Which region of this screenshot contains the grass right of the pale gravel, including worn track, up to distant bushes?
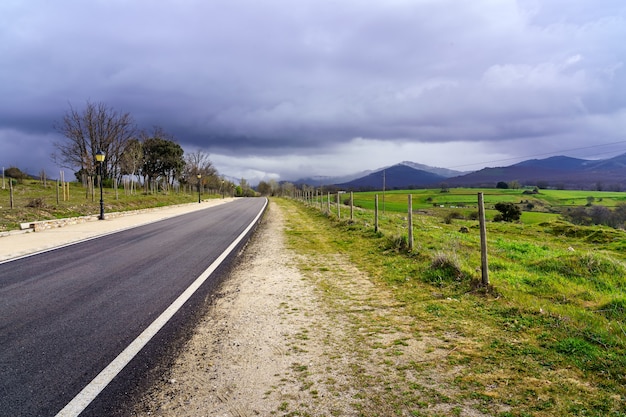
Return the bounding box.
[277,196,626,417]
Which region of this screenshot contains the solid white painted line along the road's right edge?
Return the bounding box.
[56,199,268,417]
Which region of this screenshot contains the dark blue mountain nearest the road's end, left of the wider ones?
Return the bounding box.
[336,163,446,191]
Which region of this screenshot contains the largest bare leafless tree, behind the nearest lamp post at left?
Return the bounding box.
[52,101,135,178]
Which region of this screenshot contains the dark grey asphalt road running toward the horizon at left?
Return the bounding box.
[0,198,266,416]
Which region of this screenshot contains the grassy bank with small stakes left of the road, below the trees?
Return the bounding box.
[0,179,220,232]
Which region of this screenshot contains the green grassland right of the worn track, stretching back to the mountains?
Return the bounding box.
[280,190,626,417]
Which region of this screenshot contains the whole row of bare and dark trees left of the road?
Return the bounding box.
[52,101,234,189]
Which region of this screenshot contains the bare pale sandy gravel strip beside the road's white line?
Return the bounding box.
[136,203,343,417]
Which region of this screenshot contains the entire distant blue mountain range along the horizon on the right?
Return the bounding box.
[295,153,626,191]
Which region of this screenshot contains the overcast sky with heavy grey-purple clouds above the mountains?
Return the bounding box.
[0,0,626,182]
